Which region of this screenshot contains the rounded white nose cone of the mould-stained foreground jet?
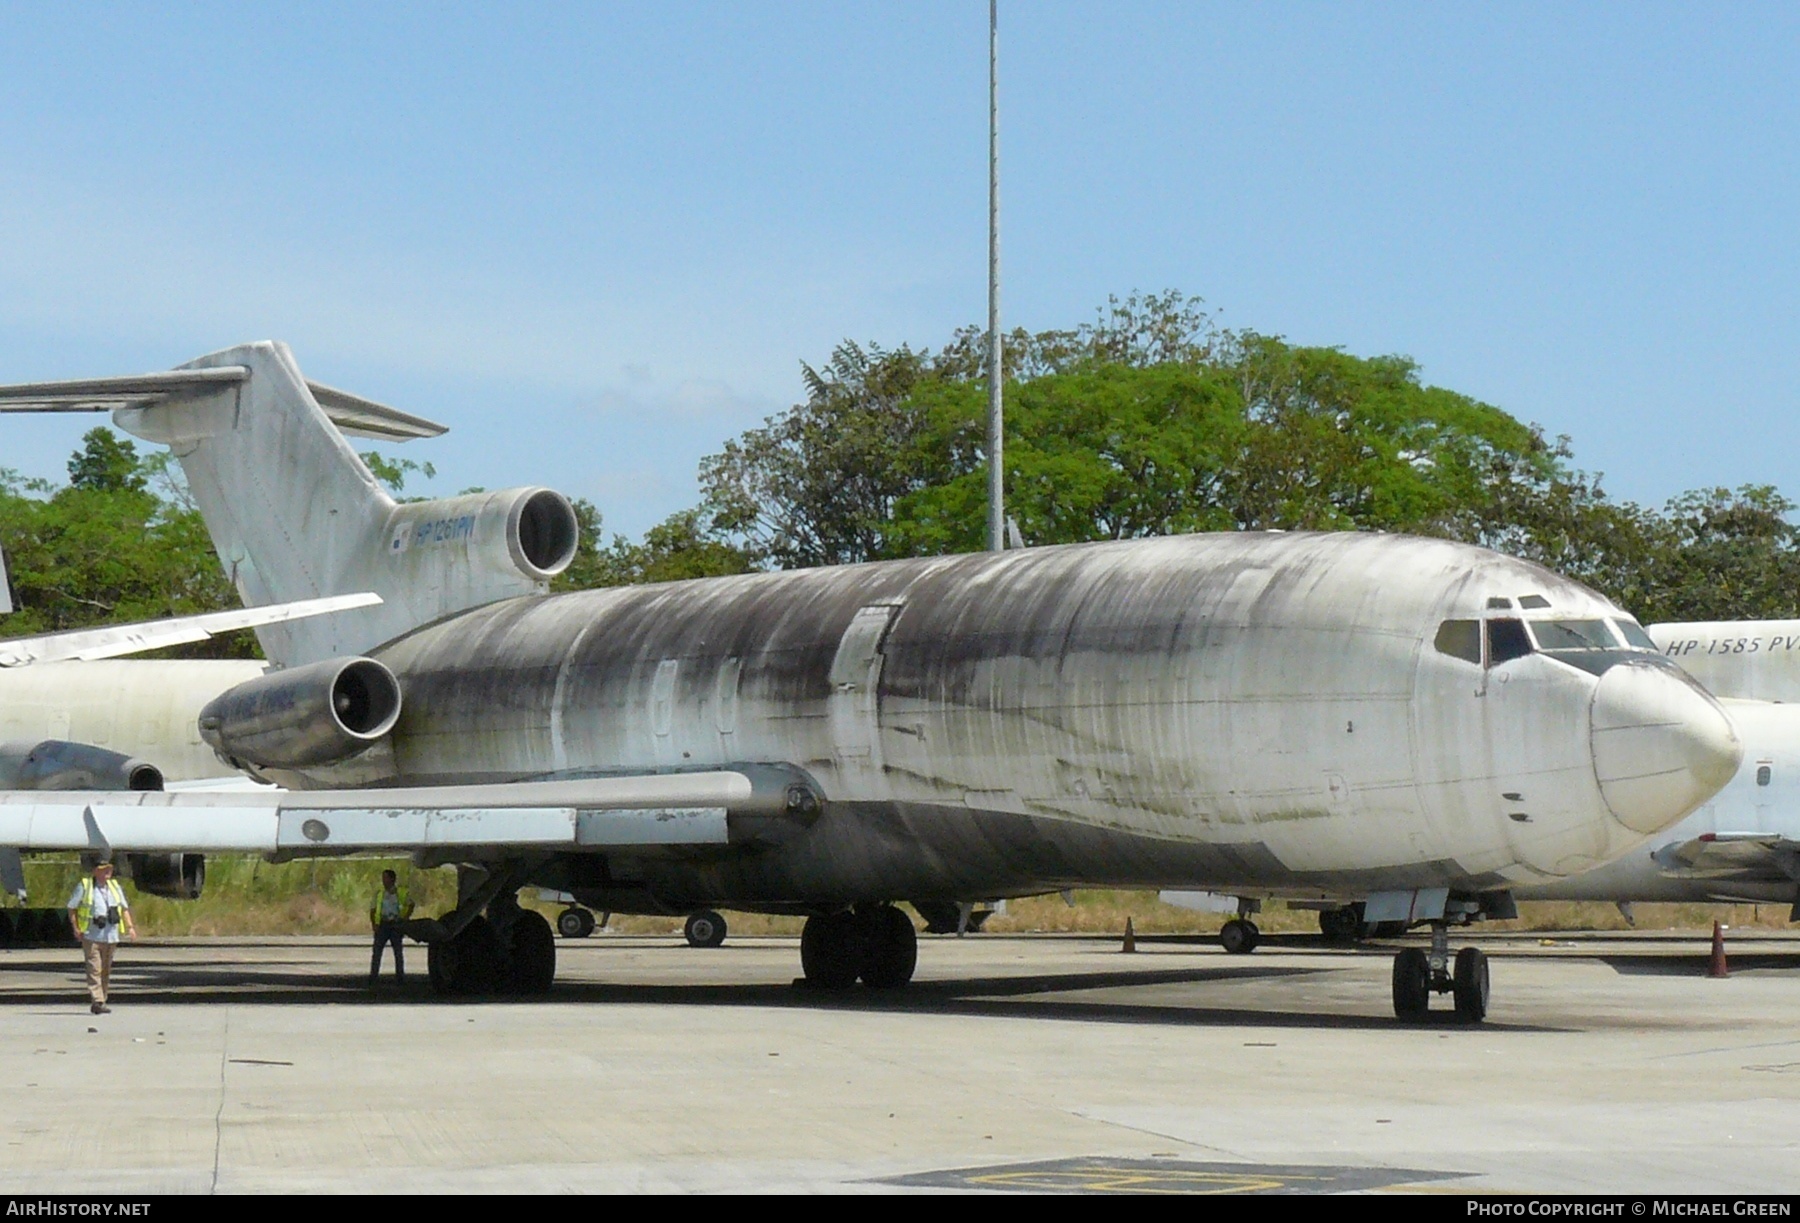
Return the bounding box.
[1593,665,1744,832]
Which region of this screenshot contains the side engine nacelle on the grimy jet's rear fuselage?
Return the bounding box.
[200,657,400,769]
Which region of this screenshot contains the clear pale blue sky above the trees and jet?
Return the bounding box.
[0,0,1800,535]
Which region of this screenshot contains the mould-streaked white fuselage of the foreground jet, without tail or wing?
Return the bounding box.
[272,533,1739,911]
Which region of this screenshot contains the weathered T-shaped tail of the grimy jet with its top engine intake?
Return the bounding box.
[0,340,576,666]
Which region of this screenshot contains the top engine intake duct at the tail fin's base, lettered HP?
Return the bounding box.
[383,488,581,584]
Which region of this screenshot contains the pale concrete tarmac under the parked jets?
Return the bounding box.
[0,933,1800,1194]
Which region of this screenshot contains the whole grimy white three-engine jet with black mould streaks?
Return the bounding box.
[0,344,1741,1019]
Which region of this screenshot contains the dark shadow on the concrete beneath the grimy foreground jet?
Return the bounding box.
[0,947,1562,1032]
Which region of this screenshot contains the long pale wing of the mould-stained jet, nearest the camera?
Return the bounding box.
[0,771,756,857]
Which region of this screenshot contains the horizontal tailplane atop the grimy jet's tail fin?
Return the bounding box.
[0,366,448,441]
